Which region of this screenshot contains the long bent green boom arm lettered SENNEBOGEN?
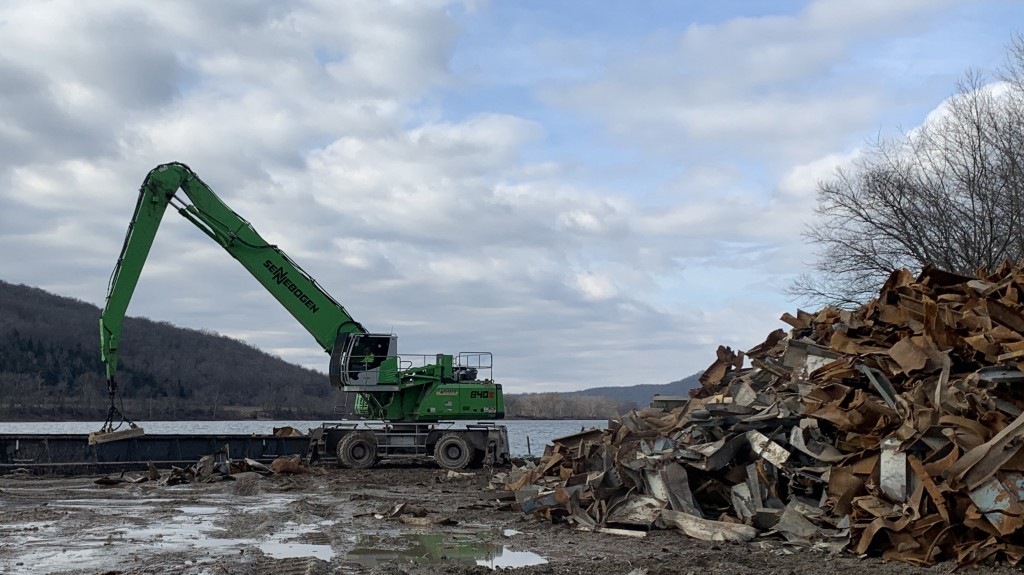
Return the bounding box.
[99,163,367,382]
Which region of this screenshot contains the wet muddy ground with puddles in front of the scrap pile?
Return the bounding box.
[0,465,1021,575]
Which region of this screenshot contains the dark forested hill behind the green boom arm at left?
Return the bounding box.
[0,281,344,421]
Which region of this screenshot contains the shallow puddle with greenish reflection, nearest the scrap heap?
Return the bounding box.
[347,533,548,569]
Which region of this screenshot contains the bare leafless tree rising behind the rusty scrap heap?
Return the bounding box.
[790,36,1024,306]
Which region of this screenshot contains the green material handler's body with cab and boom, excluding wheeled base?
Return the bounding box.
[99,163,505,422]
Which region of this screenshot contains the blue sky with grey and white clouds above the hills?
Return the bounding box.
[0,0,1024,393]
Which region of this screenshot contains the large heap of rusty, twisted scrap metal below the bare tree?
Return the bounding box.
[505,264,1024,565]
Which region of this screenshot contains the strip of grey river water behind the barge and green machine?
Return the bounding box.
[0,419,608,456]
